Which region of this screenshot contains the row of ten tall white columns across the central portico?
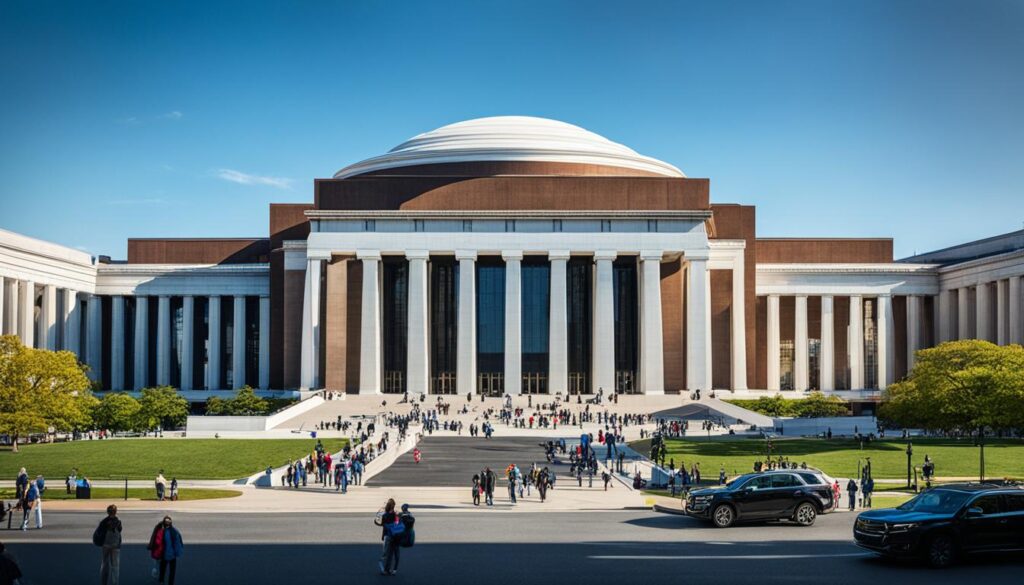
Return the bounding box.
[300,250,746,394]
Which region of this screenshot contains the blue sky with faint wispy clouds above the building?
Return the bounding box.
[0,0,1024,258]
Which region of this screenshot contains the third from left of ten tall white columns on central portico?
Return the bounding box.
[406,250,428,394]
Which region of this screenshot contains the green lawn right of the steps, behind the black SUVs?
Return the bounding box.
[632,438,1024,485]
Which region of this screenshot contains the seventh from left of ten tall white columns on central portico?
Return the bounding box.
[591,250,617,394]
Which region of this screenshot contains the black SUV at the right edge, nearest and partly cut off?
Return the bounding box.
[853,484,1024,568]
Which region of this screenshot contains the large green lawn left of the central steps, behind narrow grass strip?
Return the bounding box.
[0,438,345,481]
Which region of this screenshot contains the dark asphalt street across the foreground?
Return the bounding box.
[0,508,1024,585]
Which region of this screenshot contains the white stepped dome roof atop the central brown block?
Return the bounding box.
[334,116,686,178]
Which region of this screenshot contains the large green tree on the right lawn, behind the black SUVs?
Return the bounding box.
[879,339,1024,477]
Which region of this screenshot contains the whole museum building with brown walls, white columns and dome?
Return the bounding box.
[0,117,1024,402]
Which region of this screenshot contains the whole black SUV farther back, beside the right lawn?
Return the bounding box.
[685,469,833,528]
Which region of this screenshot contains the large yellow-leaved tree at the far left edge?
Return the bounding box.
[0,335,96,452]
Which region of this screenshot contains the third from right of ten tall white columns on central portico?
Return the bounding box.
[640,250,665,394]
